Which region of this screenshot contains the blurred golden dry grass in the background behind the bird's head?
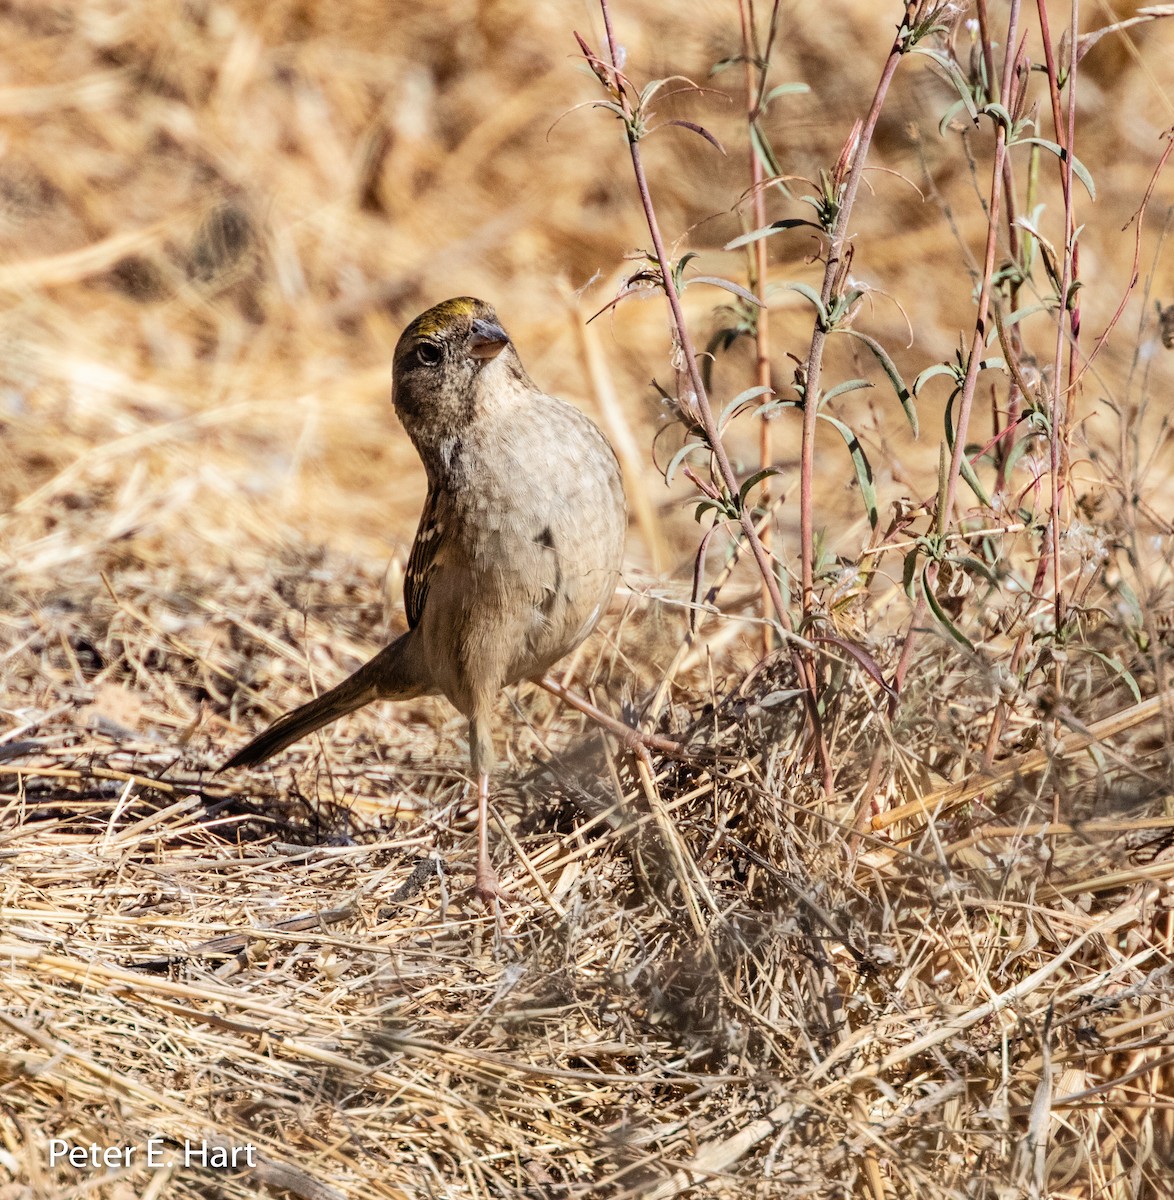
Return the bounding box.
[0,0,1174,600]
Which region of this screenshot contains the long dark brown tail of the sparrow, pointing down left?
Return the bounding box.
[216,632,430,774]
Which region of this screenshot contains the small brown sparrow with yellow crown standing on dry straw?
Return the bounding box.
[221,296,627,901]
